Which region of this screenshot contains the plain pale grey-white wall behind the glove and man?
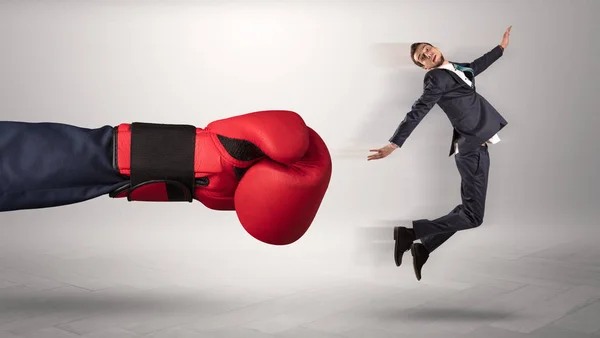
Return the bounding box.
[0,0,600,240]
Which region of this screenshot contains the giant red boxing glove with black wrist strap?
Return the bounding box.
[110,110,332,245]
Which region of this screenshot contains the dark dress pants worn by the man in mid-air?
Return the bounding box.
[413,144,490,252]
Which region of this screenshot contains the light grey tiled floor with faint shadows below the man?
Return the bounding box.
[0,201,600,338]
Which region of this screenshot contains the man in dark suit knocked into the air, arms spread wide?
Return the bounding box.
[367,26,512,280]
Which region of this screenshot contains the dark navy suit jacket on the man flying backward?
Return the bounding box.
[389,45,508,156]
